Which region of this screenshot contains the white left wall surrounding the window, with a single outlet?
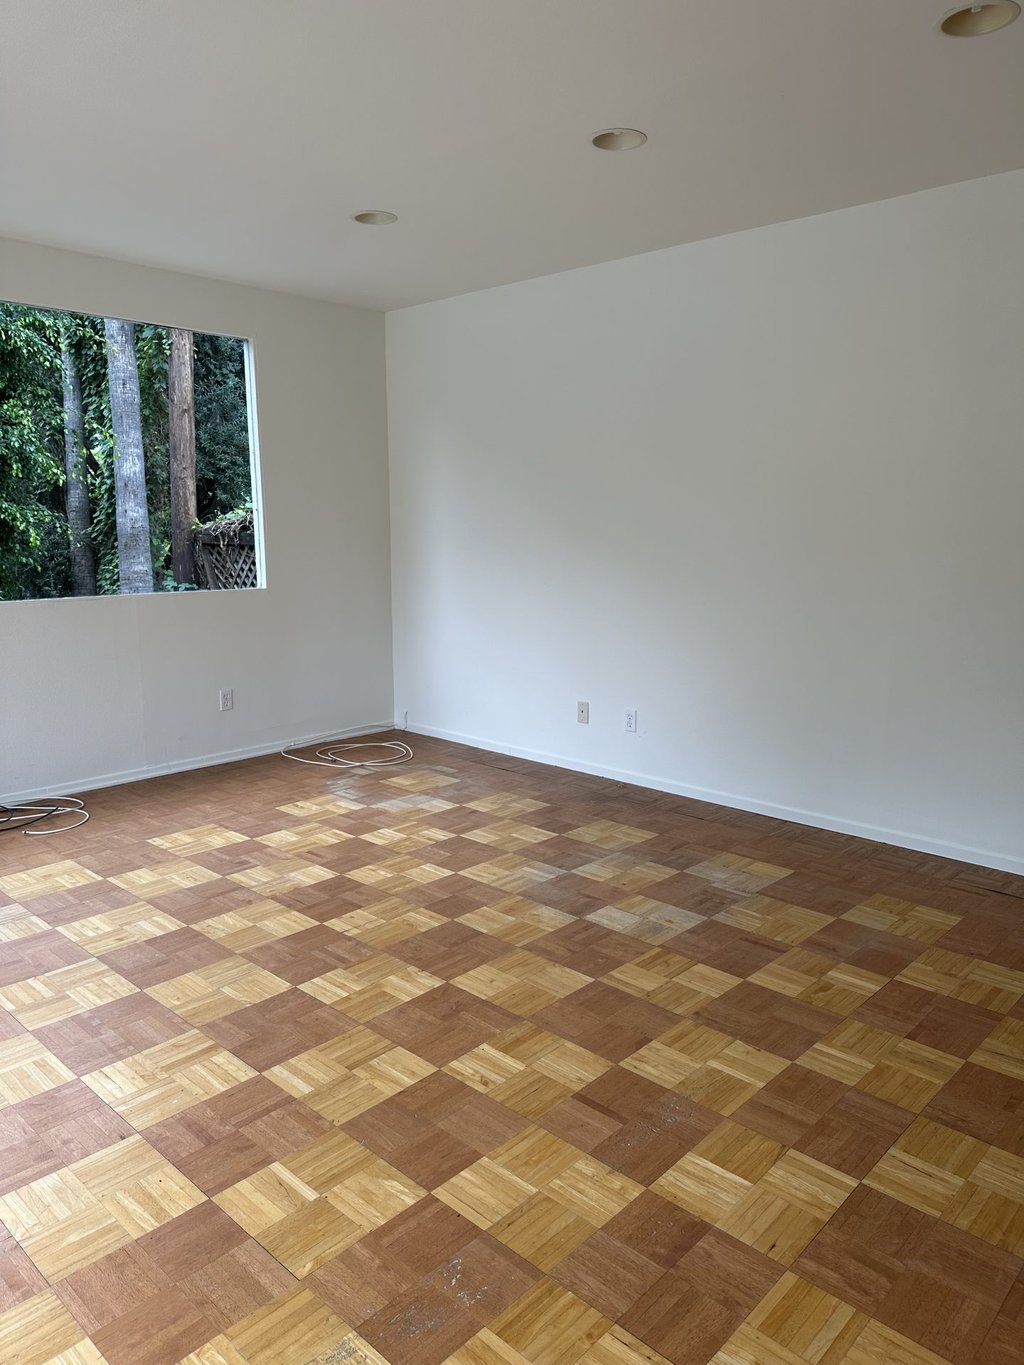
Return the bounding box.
[0,242,393,797]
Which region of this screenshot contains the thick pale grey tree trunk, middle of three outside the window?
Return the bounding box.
[104,318,153,592]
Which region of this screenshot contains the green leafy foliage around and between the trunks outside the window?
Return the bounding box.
[0,303,253,599]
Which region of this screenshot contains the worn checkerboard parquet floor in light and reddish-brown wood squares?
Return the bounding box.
[0,740,1024,1365]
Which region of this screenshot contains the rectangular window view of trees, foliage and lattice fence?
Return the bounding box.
[0,303,257,601]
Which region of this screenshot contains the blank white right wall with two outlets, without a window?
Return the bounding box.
[388,172,1024,871]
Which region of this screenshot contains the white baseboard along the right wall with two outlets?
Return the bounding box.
[408,722,1024,876]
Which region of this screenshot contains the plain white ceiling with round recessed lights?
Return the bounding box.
[0,0,1024,307]
